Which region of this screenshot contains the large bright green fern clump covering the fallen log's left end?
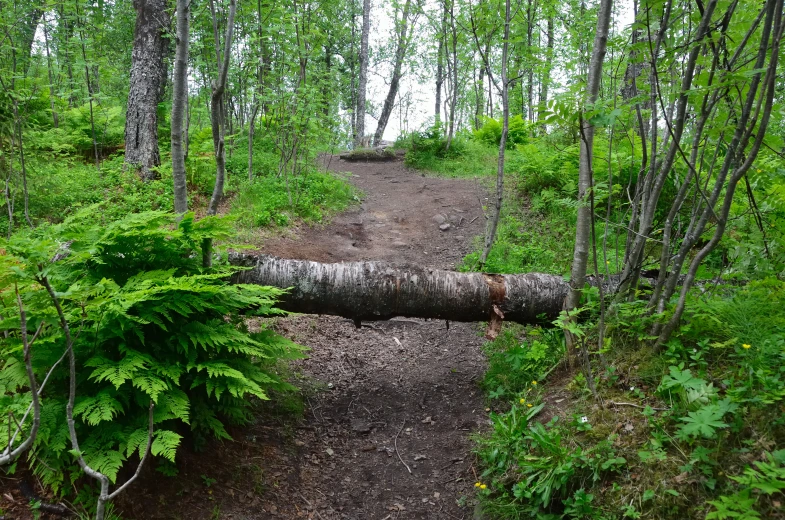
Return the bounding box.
[0,208,301,493]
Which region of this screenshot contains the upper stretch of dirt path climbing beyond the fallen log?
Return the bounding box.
[262,153,484,269]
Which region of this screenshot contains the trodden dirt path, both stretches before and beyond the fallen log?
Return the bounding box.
[254,159,485,520]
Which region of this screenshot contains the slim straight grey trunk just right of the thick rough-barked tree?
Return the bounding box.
[171,0,189,215]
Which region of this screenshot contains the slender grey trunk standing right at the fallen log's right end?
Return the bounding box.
[564,0,613,358]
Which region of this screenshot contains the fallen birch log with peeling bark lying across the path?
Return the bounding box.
[230,253,569,323]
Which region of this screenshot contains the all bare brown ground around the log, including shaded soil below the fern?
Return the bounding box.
[118,153,487,520]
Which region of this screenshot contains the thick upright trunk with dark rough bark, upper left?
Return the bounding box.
[125,0,169,180]
